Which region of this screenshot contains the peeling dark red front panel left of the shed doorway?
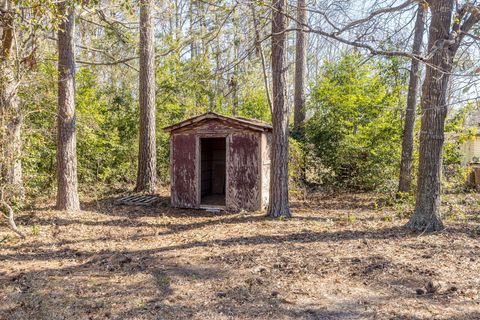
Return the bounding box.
[171,134,198,208]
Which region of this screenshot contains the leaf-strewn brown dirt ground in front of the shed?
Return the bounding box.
[0,194,480,320]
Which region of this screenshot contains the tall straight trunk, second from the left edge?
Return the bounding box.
[57,2,80,211]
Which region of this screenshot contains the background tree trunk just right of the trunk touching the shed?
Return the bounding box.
[293,0,307,133]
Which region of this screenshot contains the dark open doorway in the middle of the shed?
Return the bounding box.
[200,138,227,206]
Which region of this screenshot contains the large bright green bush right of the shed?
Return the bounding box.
[305,53,404,190]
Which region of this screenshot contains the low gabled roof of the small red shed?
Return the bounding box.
[163,112,272,132]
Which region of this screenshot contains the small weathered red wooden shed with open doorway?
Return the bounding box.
[164,112,272,211]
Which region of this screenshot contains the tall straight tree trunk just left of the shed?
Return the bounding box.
[135,0,157,193]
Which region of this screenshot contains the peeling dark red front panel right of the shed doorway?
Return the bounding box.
[226,131,261,211]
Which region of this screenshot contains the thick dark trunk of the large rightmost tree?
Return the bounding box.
[407,0,454,231]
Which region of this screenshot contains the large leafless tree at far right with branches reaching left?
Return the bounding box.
[280,0,480,231]
